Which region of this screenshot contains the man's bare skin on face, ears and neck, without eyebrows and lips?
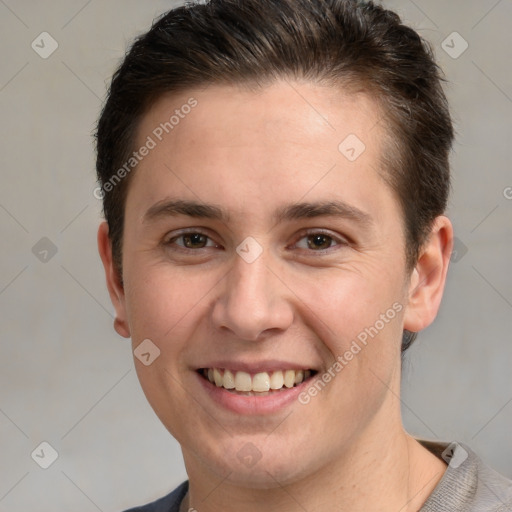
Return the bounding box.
[98,81,453,512]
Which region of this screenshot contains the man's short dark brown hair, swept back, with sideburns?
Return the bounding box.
[96,0,453,349]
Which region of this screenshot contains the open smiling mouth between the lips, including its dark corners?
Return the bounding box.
[198,368,317,396]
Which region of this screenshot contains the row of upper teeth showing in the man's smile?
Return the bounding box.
[206,368,311,392]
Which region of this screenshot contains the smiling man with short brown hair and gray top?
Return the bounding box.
[97,0,512,512]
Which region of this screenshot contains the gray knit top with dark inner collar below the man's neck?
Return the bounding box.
[126,439,512,512]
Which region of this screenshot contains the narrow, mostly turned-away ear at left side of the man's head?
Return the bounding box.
[98,221,130,338]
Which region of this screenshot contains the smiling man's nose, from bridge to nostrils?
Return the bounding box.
[212,247,293,341]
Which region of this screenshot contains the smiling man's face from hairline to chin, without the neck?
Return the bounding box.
[99,82,440,487]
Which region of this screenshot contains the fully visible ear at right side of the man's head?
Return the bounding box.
[404,215,453,332]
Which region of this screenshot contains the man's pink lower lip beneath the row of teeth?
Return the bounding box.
[196,372,312,415]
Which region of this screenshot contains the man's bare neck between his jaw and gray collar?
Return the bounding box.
[182,414,446,512]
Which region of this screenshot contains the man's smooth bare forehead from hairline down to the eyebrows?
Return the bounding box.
[129,80,391,224]
